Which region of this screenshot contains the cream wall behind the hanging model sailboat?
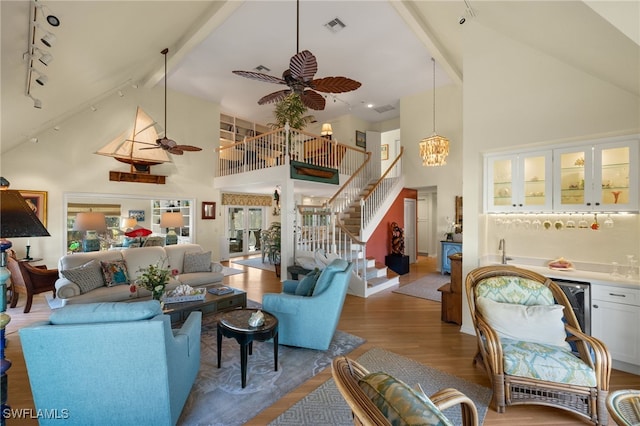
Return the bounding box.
[0,88,223,267]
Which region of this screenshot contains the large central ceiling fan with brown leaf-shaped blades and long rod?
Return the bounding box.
[233,0,362,111]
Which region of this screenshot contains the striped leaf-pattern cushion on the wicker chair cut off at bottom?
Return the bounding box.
[358,373,452,426]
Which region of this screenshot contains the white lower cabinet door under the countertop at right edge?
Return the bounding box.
[591,299,640,365]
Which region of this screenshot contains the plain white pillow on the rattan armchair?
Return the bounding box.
[476,296,571,350]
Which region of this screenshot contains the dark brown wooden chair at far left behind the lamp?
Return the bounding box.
[7,254,58,314]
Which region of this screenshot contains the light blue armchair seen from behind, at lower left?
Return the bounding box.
[20,300,202,426]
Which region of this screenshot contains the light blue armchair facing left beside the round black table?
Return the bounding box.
[262,259,353,350]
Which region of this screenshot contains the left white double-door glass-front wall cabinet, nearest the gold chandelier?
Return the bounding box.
[485,150,553,213]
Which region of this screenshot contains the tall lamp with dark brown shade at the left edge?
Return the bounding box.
[0,178,50,426]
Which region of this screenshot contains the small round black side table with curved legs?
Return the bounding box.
[218,309,278,388]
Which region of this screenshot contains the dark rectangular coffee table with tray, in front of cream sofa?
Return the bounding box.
[163,286,247,324]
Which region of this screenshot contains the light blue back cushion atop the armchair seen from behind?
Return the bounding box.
[49,300,162,325]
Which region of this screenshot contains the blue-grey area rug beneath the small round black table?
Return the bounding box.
[178,310,365,426]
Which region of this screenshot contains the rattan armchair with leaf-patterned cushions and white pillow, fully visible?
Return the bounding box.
[466,265,611,425]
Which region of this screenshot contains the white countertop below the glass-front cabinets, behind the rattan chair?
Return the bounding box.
[480,256,640,289]
